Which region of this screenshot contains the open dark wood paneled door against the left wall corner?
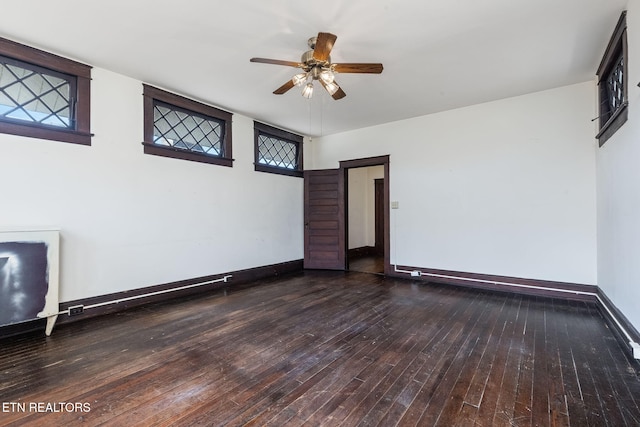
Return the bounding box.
[304,169,345,270]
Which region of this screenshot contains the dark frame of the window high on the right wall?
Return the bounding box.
[596,11,629,147]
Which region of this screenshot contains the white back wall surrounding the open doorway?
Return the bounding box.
[309,82,597,284]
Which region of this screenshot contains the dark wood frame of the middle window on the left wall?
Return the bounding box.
[142,84,233,167]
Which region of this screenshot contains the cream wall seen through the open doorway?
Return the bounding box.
[347,166,384,249]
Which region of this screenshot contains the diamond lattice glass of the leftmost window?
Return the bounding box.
[0,57,71,128]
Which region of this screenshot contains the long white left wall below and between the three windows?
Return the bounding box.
[0,68,303,301]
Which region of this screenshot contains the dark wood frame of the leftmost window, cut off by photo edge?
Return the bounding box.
[0,37,93,145]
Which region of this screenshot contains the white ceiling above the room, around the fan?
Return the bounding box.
[0,0,628,136]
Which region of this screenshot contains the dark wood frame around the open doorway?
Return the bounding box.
[340,154,392,276]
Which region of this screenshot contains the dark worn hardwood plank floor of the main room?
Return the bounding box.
[0,271,640,426]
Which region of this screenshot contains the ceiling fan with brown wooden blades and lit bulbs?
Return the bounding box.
[250,33,382,99]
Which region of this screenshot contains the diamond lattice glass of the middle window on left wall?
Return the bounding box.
[153,103,224,156]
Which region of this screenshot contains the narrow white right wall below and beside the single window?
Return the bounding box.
[594,0,640,330]
